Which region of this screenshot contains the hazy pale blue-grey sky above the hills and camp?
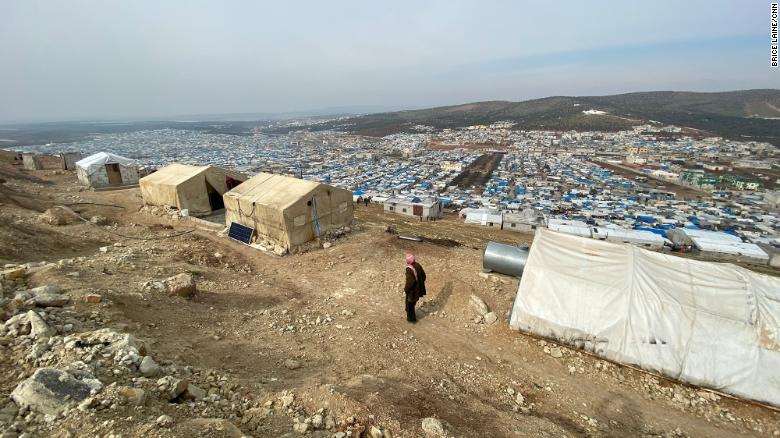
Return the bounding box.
[0,0,780,121]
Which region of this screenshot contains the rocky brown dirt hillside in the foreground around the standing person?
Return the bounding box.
[0,154,780,438]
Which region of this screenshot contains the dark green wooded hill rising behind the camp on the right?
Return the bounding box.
[272,90,780,145]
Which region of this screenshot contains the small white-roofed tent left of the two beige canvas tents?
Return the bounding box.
[76,152,138,188]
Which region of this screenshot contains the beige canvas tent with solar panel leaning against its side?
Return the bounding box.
[224,173,353,251]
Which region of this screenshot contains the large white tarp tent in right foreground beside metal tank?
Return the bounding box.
[510,228,780,406]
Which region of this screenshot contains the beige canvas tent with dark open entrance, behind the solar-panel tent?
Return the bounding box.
[139,163,246,216]
